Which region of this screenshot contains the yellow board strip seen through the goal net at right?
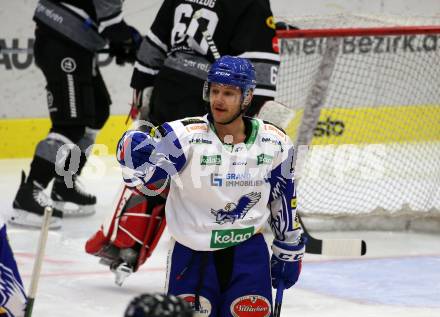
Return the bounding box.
[286,105,440,145]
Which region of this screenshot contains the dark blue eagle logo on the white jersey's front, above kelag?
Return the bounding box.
[211,192,261,225]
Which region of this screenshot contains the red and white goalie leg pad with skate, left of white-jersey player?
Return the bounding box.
[85,186,166,286]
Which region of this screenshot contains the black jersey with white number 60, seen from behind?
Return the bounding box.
[131,0,279,123]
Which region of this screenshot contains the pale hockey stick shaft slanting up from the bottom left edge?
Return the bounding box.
[24,207,53,317]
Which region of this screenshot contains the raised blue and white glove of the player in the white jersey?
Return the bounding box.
[117,130,155,172]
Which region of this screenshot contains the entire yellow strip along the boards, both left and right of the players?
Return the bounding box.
[0,105,440,159]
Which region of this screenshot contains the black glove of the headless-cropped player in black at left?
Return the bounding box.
[109,26,142,65]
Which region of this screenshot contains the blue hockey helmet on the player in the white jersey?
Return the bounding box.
[203,55,257,106]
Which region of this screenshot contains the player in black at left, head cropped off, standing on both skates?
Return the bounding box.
[10,0,141,228]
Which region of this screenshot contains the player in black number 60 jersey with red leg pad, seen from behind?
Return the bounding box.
[86,0,280,285]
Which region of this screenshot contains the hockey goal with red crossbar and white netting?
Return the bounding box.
[277,16,440,232]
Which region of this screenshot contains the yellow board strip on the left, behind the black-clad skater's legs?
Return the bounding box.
[0,115,129,159]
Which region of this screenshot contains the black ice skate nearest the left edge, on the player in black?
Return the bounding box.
[9,172,63,229]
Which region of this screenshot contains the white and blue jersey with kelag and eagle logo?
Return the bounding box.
[117,116,300,251]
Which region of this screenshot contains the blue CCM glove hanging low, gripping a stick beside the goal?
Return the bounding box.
[270,237,305,289]
